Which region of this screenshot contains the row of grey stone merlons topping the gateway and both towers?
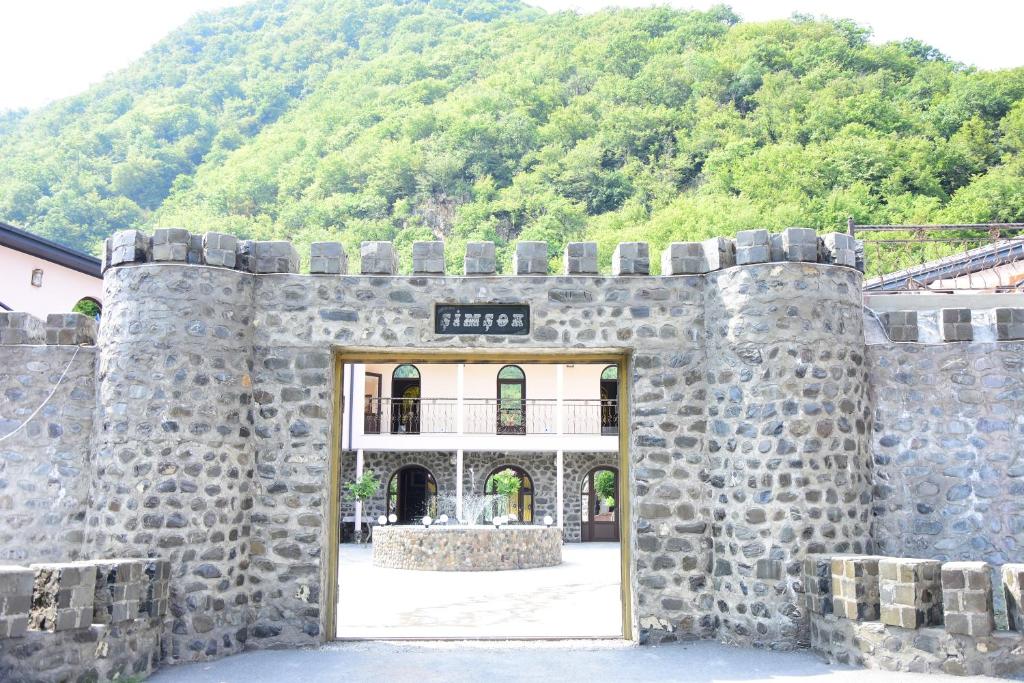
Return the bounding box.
[97,227,863,276]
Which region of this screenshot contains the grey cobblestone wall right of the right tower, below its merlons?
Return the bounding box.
[867,341,1024,566]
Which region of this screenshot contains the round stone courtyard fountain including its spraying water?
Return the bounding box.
[373,494,562,571]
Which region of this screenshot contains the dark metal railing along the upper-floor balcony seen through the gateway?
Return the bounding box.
[362,398,618,435]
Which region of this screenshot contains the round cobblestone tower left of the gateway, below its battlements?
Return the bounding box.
[87,263,253,661]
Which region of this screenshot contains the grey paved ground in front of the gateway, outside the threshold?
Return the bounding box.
[150,641,999,683]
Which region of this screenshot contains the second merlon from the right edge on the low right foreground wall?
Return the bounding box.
[942,562,995,637]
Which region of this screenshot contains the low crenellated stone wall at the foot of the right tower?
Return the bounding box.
[803,555,1024,676]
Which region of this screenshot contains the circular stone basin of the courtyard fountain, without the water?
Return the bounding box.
[373,524,562,571]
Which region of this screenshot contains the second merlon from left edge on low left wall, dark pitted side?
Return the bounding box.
[29,562,96,631]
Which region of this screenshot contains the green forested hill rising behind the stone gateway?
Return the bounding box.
[0,0,1024,271]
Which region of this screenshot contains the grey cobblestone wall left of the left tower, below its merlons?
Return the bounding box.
[0,345,96,563]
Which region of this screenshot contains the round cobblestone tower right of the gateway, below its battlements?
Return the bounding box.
[705,262,870,649]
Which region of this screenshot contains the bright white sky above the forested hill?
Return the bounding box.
[0,0,1024,111]
